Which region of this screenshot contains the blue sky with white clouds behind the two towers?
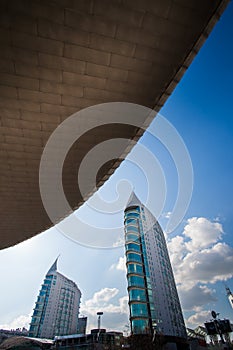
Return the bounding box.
[0,3,233,330]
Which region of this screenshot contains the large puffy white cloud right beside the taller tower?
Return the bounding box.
[167,217,233,320]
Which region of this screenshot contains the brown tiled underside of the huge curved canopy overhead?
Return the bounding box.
[0,0,228,249]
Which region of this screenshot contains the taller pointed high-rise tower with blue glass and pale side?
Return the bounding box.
[124,193,186,338]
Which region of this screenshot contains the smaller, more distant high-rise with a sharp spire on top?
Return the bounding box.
[29,259,81,339]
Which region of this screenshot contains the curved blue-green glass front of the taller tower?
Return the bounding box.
[124,206,154,334]
